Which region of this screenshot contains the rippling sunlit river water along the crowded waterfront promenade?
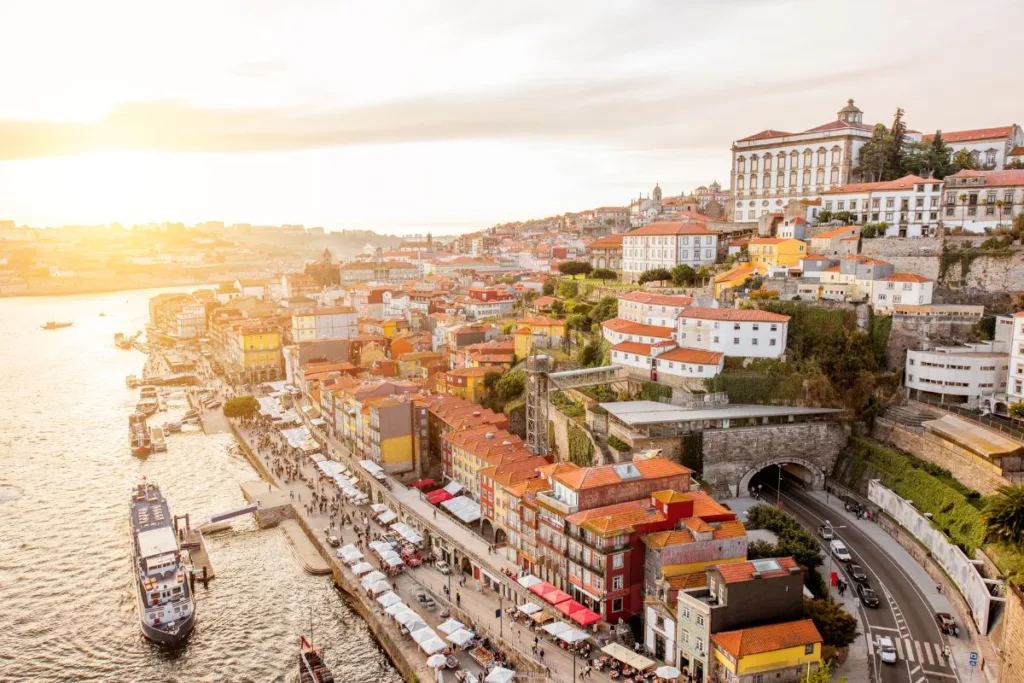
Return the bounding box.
[0,290,400,683]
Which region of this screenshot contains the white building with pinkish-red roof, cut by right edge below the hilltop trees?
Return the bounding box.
[942,170,1024,232]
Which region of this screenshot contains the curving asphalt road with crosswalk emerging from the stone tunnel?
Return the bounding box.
[763,476,957,683]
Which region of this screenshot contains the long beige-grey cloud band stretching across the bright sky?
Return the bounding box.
[0,65,905,160]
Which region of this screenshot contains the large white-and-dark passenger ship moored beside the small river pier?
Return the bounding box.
[130,481,196,645]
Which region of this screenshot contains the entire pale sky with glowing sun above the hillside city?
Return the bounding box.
[0,0,1024,234]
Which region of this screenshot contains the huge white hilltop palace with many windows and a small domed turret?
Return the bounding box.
[731,99,920,222]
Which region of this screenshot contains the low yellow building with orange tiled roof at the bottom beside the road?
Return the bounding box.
[711,618,821,683]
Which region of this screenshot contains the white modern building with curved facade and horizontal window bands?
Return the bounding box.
[905,341,1007,402]
